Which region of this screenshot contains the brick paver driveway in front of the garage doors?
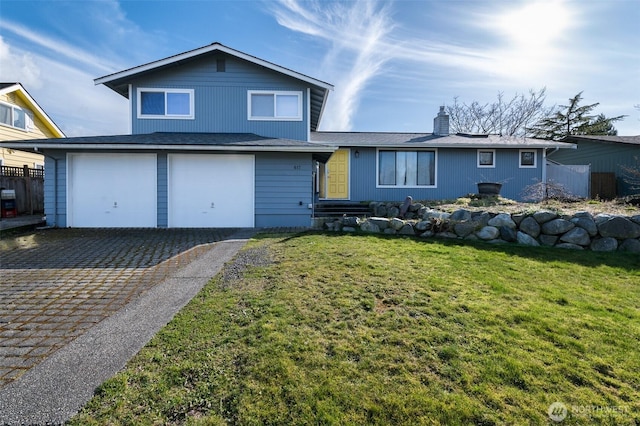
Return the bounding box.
[0,229,236,387]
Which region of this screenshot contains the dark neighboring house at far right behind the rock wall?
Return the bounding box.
[549,136,640,198]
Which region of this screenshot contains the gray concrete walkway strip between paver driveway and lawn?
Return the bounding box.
[0,230,255,424]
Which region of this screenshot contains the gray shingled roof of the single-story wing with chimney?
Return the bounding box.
[311,132,575,148]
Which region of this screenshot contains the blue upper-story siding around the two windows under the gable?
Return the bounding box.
[130,55,309,140]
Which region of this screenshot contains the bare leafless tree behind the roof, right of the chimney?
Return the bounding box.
[447,88,553,136]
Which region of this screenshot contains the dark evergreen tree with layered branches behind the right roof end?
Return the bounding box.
[529,92,625,140]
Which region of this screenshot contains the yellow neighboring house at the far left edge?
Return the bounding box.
[0,83,65,169]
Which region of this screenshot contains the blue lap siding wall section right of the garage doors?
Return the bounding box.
[255,153,313,228]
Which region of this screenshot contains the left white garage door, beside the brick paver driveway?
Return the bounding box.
[67,153,157,228]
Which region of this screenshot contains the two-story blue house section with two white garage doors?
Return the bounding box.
[1,43,335,228]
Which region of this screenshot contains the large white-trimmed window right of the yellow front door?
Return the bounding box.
[377,150,436,188]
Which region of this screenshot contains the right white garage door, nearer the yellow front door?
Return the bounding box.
[169,154,255,228]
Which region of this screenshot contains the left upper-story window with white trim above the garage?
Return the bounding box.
[138,88,194,119]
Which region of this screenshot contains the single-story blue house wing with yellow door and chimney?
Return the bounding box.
[311,107,574,202]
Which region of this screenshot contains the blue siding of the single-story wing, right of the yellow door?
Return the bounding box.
[350,147,542,201]
